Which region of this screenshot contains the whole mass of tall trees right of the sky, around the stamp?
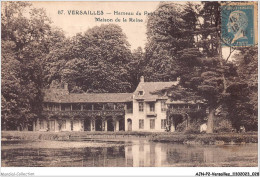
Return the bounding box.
[146,2,257,133]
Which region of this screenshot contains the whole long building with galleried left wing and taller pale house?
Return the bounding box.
[33,77,203,132]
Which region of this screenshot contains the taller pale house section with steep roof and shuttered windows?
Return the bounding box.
[125,77,178,132]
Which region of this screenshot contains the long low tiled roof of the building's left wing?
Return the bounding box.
[44,89,132,103]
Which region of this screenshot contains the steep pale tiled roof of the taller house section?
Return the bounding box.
[134,81,178,101]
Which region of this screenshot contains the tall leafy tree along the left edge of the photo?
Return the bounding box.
[1,2,53,129]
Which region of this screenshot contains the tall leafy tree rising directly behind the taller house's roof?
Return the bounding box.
[145,2,190,81]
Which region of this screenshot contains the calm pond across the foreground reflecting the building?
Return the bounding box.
[1,140,258,167]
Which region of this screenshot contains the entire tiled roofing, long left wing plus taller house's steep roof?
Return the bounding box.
[44,81,178,103]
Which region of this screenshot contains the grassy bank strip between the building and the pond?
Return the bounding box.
[1,131,258,145]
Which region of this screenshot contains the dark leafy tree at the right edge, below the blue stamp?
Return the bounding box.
[226,47,258,130]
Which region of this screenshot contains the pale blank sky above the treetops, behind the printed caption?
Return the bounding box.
[31,1,235,59]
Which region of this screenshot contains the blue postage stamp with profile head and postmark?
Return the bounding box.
[221,2,257,47]
